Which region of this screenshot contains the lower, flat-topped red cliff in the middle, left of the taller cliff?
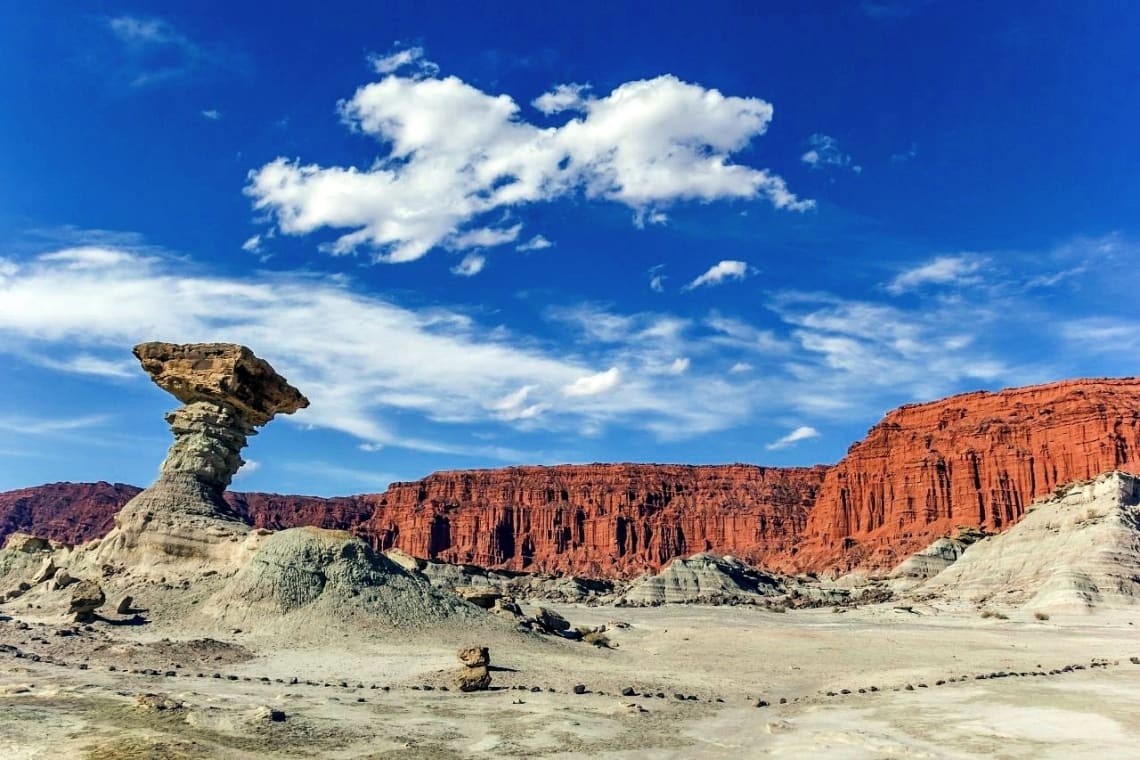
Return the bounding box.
[357,464,827,575]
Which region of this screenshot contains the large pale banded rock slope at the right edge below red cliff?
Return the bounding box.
[912,472,1140,612]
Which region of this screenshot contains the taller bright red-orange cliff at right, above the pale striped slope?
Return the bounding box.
[782,378,1140,570]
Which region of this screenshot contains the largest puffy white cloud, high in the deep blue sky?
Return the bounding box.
[246,63,813,262]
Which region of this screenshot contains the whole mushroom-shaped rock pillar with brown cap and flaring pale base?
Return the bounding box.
[90,343,309,564]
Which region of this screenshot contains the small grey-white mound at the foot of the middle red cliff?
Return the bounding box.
[622,554,783,604]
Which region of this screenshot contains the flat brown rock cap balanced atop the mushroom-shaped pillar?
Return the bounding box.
[135,341,309,426]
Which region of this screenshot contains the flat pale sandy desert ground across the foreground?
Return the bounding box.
[0,604,1140,759]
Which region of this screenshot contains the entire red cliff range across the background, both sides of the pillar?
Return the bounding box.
[0,378,1140,578]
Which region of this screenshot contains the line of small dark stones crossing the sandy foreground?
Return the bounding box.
[0,644,1140,708]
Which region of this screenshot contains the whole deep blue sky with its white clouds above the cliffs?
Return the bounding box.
[0,0,1140,495]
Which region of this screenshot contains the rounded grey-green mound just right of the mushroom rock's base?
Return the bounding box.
[204,528,474,632]
